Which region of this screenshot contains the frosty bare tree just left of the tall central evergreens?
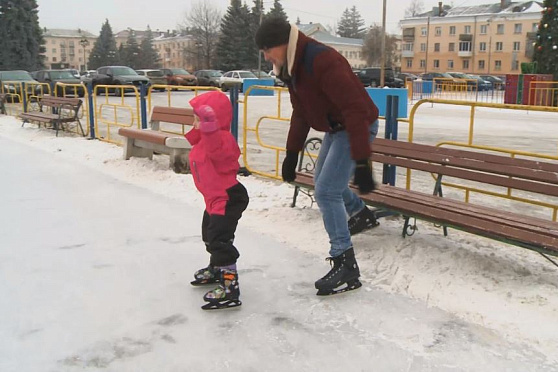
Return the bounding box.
[178,0,222,70]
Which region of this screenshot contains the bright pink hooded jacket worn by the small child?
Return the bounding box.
[185,91,240,215]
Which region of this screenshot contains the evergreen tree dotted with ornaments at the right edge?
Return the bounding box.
[533,0,558,80]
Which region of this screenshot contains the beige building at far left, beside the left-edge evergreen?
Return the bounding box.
[43,28,97,71]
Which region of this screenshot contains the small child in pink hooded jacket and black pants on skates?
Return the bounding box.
[185,91,249,310]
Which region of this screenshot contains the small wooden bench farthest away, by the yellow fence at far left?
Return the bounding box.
[19,96,85,137]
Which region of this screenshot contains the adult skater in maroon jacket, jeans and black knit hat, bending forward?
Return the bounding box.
[256,18,378,295]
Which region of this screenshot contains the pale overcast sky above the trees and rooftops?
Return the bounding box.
[37,0,499,34]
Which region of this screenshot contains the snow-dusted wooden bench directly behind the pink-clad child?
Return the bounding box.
[118,106,194,173]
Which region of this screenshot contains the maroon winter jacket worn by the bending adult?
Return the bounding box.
[287,29,378,160]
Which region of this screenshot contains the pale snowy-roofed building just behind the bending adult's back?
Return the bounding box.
[297,23,366,68]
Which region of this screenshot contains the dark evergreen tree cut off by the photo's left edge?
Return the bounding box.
[0,0,45,71]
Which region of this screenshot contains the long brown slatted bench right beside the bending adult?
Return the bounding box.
[294,138,558,257]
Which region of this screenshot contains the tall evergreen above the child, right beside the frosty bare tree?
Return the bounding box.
[217,0,257,71]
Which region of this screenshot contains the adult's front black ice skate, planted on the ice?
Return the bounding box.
[315,248,362,296]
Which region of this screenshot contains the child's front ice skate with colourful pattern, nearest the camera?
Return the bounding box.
[202,270,242,310]
